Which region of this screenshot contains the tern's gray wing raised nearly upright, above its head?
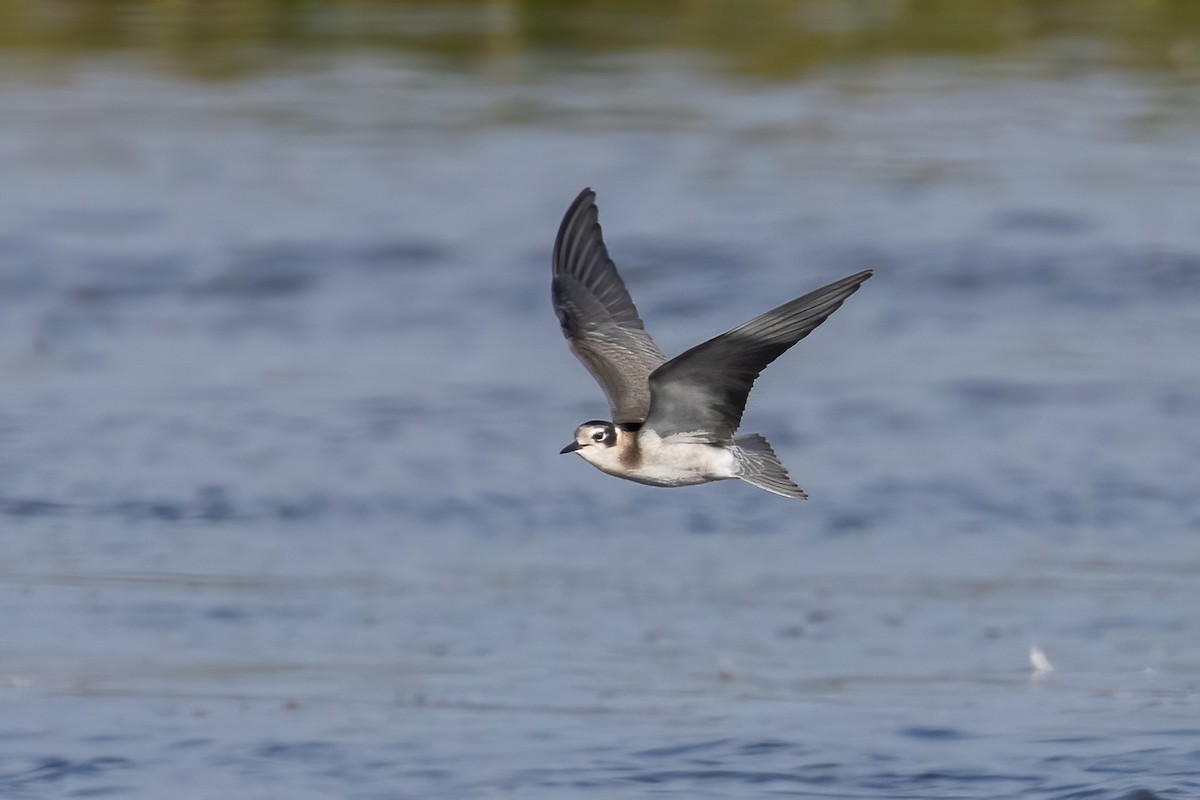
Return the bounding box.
[551,188,666,422]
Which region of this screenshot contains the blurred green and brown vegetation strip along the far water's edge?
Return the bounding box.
[0,0,1200,80]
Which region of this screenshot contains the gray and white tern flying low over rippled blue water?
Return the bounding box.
[551,188,871,500]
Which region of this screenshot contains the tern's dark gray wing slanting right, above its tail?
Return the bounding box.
[646,270,871,443]
